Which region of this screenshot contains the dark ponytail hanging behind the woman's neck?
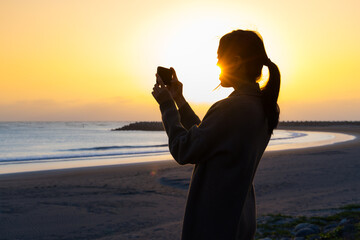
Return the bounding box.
[261,59,280,134]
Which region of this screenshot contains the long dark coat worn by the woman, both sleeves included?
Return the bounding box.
[160,84,270,240]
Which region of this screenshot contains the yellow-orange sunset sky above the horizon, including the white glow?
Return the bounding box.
[0,0,360,121]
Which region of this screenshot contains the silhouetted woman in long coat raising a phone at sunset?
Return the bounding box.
[152,30,280,240]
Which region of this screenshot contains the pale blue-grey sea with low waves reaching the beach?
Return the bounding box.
[0,122,354,174]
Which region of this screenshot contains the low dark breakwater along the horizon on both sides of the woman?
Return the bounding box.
[111,121,360,131]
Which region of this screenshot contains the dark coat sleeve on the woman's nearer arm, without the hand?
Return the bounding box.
[160,101,223,165]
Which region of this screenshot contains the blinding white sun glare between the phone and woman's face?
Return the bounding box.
[157,19,236,103]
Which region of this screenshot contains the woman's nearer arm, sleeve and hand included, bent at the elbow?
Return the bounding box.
[152,70,235,165]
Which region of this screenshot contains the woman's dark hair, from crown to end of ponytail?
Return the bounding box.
[218,30,280,133]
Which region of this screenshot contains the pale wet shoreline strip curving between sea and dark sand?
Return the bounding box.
[0,126,360,176]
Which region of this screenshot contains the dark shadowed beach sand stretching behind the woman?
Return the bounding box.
[0,126,360,240]
